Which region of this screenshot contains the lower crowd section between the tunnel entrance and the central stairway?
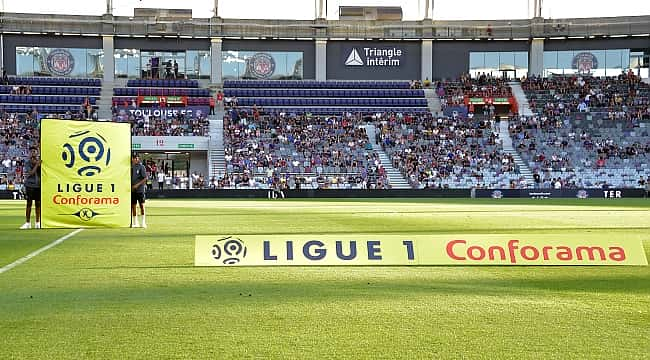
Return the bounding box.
[218,114,390,189]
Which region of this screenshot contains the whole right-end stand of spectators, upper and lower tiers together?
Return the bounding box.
[510,72,650,189]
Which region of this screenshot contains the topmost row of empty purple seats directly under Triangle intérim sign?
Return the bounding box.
[223,80,410,89]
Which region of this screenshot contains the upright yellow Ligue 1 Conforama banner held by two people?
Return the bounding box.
[41,119,131,228]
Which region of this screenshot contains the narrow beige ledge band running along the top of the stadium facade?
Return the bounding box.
[0,13,650,40]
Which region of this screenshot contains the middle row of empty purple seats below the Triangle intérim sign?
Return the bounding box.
[224,88,424,97]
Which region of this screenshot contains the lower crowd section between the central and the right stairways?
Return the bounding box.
[378,115,526,189]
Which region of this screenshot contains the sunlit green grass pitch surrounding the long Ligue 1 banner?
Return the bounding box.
[0,199,650,359]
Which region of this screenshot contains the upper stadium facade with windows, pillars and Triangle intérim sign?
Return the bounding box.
[1,13,650,84]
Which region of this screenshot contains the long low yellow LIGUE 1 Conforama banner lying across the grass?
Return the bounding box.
[194,234,648,266]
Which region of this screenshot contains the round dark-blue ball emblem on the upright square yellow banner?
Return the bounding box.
[61,130,111,177]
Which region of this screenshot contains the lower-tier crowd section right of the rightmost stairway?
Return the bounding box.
[510,115,650,189]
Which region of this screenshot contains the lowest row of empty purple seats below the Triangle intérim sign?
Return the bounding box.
[237,98,427,106]
